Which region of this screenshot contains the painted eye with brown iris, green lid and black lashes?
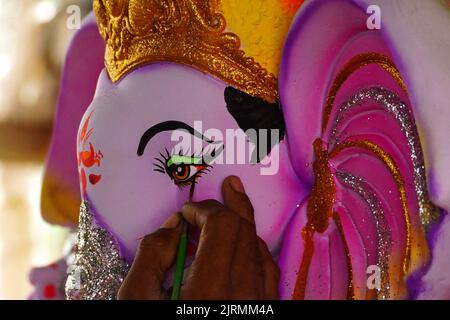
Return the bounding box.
[154,154,209,186]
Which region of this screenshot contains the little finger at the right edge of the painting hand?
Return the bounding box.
[258,238,280,300]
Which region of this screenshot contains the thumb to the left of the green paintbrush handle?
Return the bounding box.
[117,214,182,300]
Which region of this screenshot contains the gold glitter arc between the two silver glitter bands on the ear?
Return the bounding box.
[330,140,411,275]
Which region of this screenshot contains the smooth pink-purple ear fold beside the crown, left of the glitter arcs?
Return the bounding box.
[279,0,367,183]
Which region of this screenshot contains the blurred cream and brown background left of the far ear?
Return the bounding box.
[0,0,92,299]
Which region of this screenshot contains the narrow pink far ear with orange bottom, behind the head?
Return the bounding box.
[41,14,105,225]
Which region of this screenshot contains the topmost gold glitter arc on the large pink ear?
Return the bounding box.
[322,52,407,133]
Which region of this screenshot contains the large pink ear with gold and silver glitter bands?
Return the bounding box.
[279,0,450,299]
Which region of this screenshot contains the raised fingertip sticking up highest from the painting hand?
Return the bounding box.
[222,176,255,224]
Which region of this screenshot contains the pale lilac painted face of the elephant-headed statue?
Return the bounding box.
[78,63,305,260]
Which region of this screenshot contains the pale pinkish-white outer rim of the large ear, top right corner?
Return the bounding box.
[356,0,450,212]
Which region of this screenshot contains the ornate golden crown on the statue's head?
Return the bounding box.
[93,0,278,102]
